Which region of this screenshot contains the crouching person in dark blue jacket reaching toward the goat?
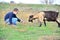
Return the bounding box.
[4,8,22,25]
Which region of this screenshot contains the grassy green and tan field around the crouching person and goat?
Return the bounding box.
[0,4,60,40]
